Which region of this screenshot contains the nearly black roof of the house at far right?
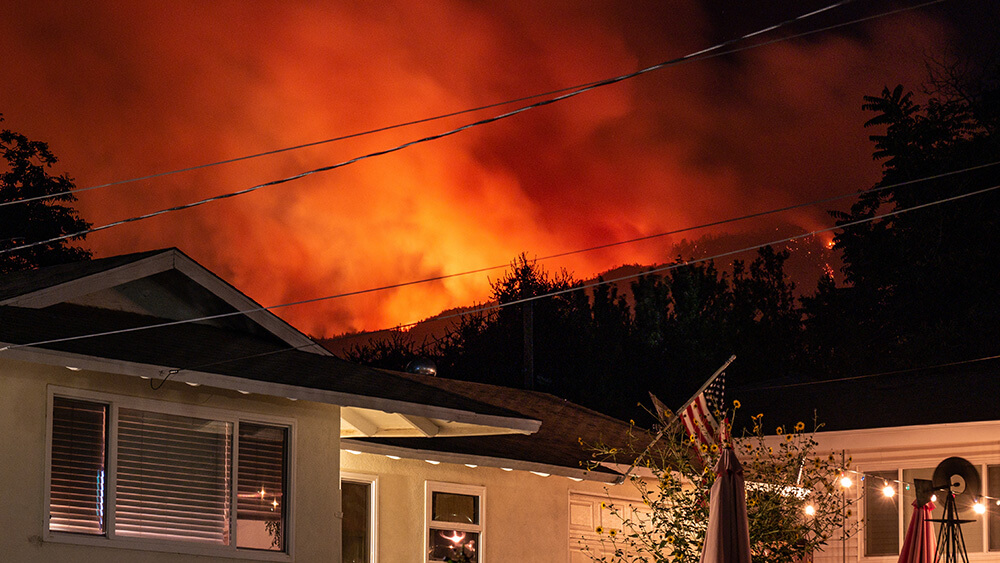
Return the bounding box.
[727,358,1000,431]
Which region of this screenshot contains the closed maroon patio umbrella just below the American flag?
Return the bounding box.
[701,448,750,563]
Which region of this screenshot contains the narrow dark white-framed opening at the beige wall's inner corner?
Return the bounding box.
[340,473,378,563]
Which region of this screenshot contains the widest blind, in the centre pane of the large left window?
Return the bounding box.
[115,408,233,545]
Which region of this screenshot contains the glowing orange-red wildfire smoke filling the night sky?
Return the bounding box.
[0,0,968,336]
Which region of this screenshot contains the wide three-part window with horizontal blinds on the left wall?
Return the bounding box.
[47,392,290,552]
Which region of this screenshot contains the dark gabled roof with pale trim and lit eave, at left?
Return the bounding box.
[0,249,539,436]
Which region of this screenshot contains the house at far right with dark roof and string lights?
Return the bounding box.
[733,364,1000,563]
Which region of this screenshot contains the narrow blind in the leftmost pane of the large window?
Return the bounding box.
[49,397,108,535]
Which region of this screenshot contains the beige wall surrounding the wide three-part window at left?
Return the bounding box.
[0,358,344,563]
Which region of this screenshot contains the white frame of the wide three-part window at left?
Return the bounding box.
[42,385,296,562]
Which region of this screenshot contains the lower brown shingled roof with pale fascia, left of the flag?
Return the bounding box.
[341,373,632,482]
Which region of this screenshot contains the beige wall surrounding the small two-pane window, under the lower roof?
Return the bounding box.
[341,451,638,563]
